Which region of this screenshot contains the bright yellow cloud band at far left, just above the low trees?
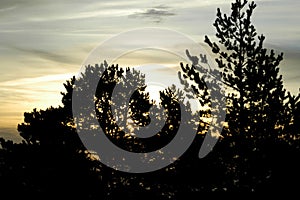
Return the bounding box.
[0,73,74,109]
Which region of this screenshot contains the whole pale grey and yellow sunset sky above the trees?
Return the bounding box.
[0,0,300,141]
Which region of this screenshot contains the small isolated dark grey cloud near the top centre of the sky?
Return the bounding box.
[128,5,176,23]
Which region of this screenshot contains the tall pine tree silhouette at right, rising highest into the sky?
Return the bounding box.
[205,0,287,140]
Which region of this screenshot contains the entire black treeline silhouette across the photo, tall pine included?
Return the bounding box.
[0,0,300,199]
